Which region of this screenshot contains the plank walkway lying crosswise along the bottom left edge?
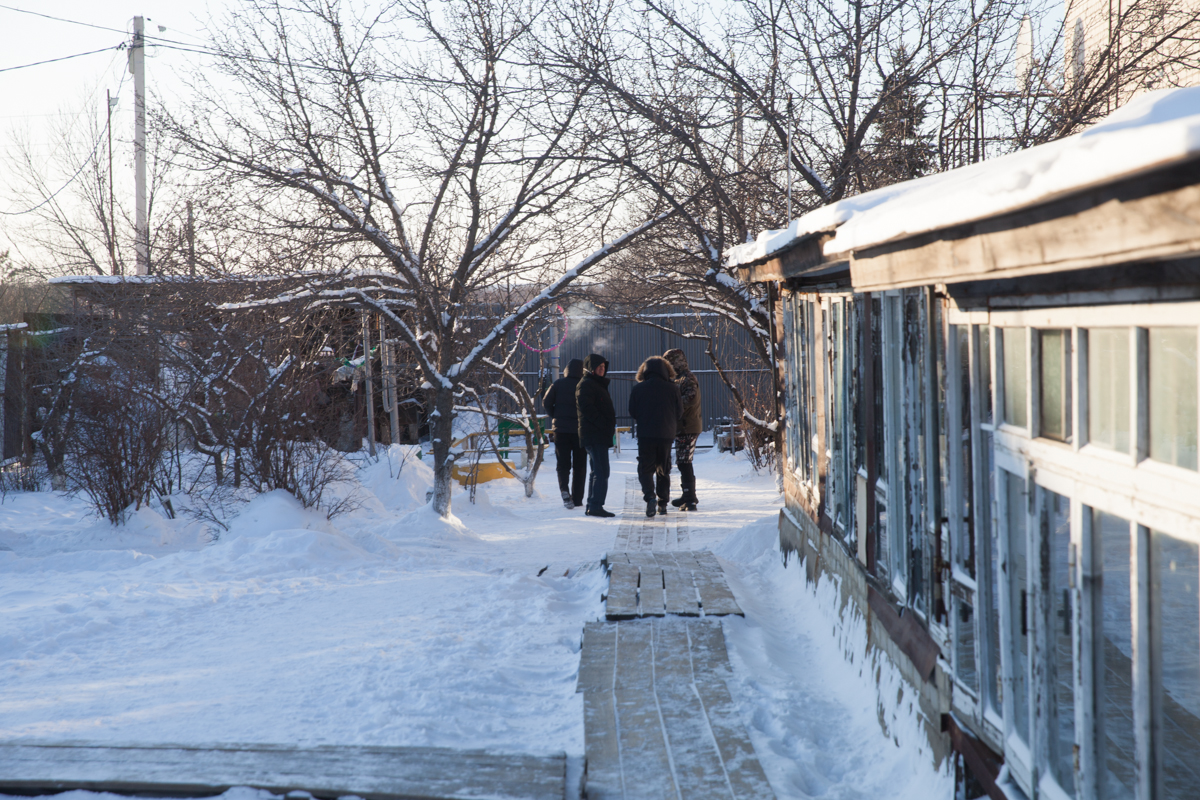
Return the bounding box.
[0,742,566,800]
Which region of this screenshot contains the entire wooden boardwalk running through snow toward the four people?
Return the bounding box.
[577,479,775,800]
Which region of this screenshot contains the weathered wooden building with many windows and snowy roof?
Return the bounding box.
[728,89,1200,800]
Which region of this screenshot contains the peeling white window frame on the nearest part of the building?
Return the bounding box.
[950,301,1200,800]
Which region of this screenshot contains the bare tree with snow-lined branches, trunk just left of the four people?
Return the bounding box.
[162,0,671,515]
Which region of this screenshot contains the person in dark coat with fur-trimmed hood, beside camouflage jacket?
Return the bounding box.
[629,355,683,517]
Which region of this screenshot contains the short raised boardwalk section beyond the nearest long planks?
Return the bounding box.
[605,551,745,620]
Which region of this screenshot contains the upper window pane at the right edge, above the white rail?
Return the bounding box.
[1150,327,1198,469]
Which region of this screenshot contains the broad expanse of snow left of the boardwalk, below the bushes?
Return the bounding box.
[0,447,600,754]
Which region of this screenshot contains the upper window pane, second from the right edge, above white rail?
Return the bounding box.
[1087,327,1129,452]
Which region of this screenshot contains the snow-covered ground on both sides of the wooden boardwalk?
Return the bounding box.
[0,441,950,800]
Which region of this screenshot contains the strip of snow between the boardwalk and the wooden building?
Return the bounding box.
[714,515,953,800]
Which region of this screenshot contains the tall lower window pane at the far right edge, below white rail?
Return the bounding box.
[1153,531,1200,800]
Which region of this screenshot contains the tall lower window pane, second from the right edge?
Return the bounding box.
[1088,510,1138,800]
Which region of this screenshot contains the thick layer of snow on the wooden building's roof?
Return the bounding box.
[725,86,1200,266]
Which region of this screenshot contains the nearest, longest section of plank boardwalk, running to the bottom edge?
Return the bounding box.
[577,616,775,800]
